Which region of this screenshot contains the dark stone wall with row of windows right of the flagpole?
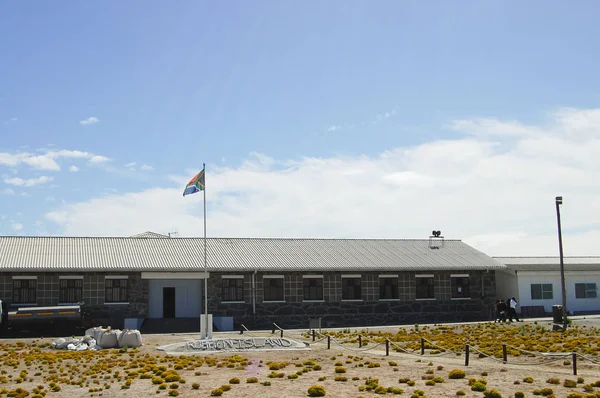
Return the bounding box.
[208,271,496,329]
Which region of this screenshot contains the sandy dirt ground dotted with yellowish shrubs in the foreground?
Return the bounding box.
[0,320,600,398]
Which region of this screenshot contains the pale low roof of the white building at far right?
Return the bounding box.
[494,256,600,271]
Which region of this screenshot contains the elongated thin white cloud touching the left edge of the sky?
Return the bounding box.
[0,150,110,171]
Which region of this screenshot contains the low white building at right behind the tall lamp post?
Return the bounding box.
[494,256,600,317]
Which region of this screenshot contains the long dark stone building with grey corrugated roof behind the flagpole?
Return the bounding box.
[0,232,506,330]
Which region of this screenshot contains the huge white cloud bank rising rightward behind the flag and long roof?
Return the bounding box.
[47,110,600,255]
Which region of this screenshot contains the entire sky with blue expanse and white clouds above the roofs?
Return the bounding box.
[0,0,600,256]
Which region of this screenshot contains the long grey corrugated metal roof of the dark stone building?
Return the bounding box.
[0,236,505,271]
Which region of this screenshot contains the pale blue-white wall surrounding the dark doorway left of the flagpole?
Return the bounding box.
[148,279,203,318]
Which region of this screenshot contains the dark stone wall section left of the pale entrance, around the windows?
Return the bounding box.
[0,272,148,328]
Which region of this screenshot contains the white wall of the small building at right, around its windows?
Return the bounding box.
[518,271,600,313]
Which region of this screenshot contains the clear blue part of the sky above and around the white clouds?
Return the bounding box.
[0,1,600,256]
